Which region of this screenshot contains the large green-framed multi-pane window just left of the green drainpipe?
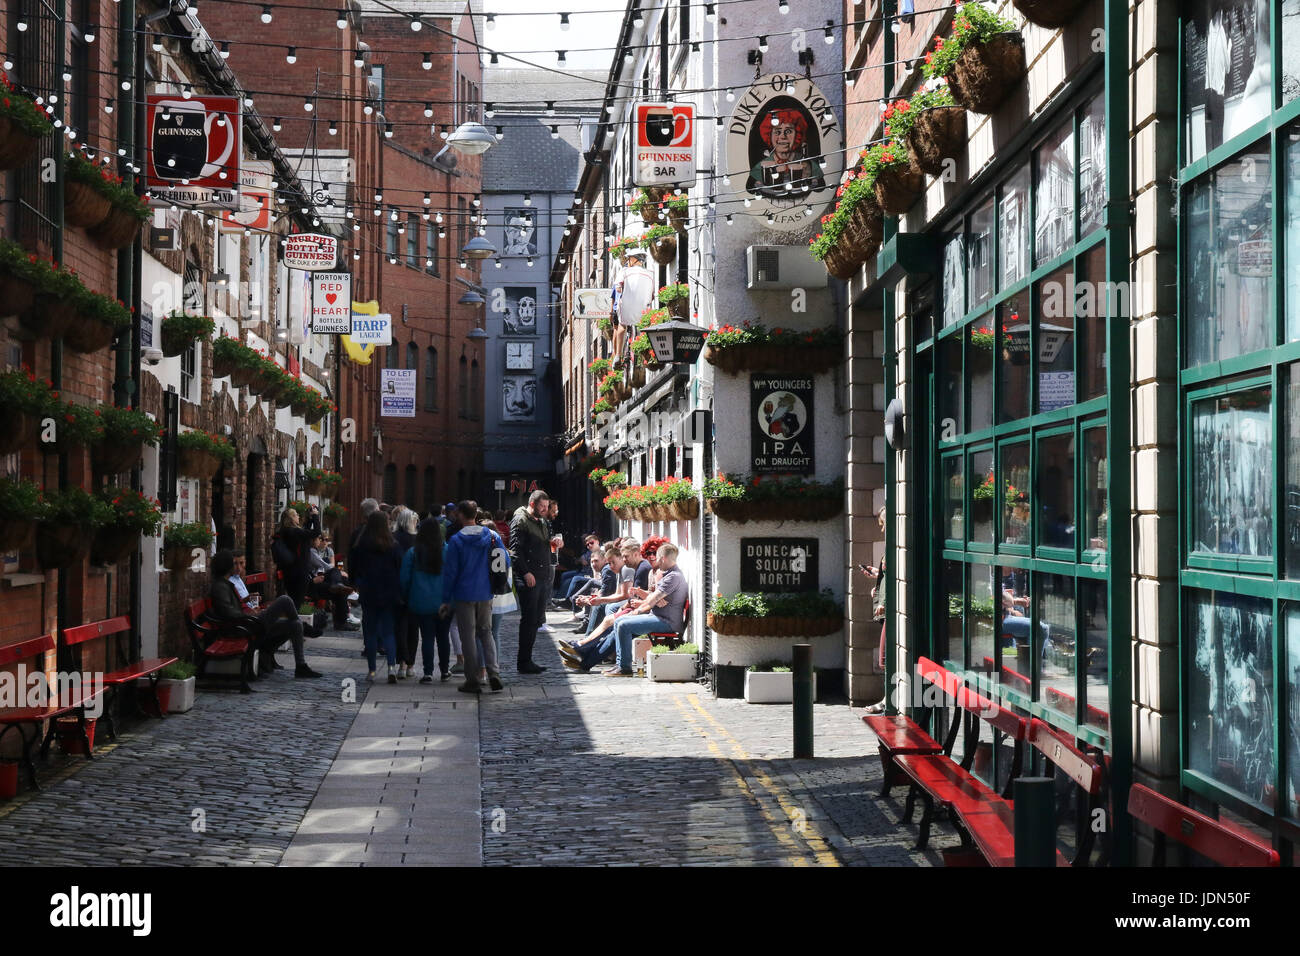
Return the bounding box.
[914,86,1127,749]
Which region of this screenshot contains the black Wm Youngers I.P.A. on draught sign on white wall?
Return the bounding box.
[749,375,815,475]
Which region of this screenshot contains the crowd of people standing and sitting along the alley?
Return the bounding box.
[202,490,686,693]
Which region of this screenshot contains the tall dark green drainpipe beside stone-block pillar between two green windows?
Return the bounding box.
[1105,0,1134,866]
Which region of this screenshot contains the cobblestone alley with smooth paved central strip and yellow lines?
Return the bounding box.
[0,614,954,866]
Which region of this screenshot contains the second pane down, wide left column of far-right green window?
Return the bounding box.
[1183,151,1273,365]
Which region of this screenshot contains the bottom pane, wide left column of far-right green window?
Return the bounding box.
[1187,591,1277,806]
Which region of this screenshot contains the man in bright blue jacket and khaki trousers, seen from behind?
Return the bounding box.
[442,501,510,693]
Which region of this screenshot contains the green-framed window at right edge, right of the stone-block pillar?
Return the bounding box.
[1177,0,1300,862]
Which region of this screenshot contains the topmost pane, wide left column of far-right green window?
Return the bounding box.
[1183,0,1273,163]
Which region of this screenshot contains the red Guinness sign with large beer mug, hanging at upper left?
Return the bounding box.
[146,94,243,209]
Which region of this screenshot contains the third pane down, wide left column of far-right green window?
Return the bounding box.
[1192,388,1273,557]
